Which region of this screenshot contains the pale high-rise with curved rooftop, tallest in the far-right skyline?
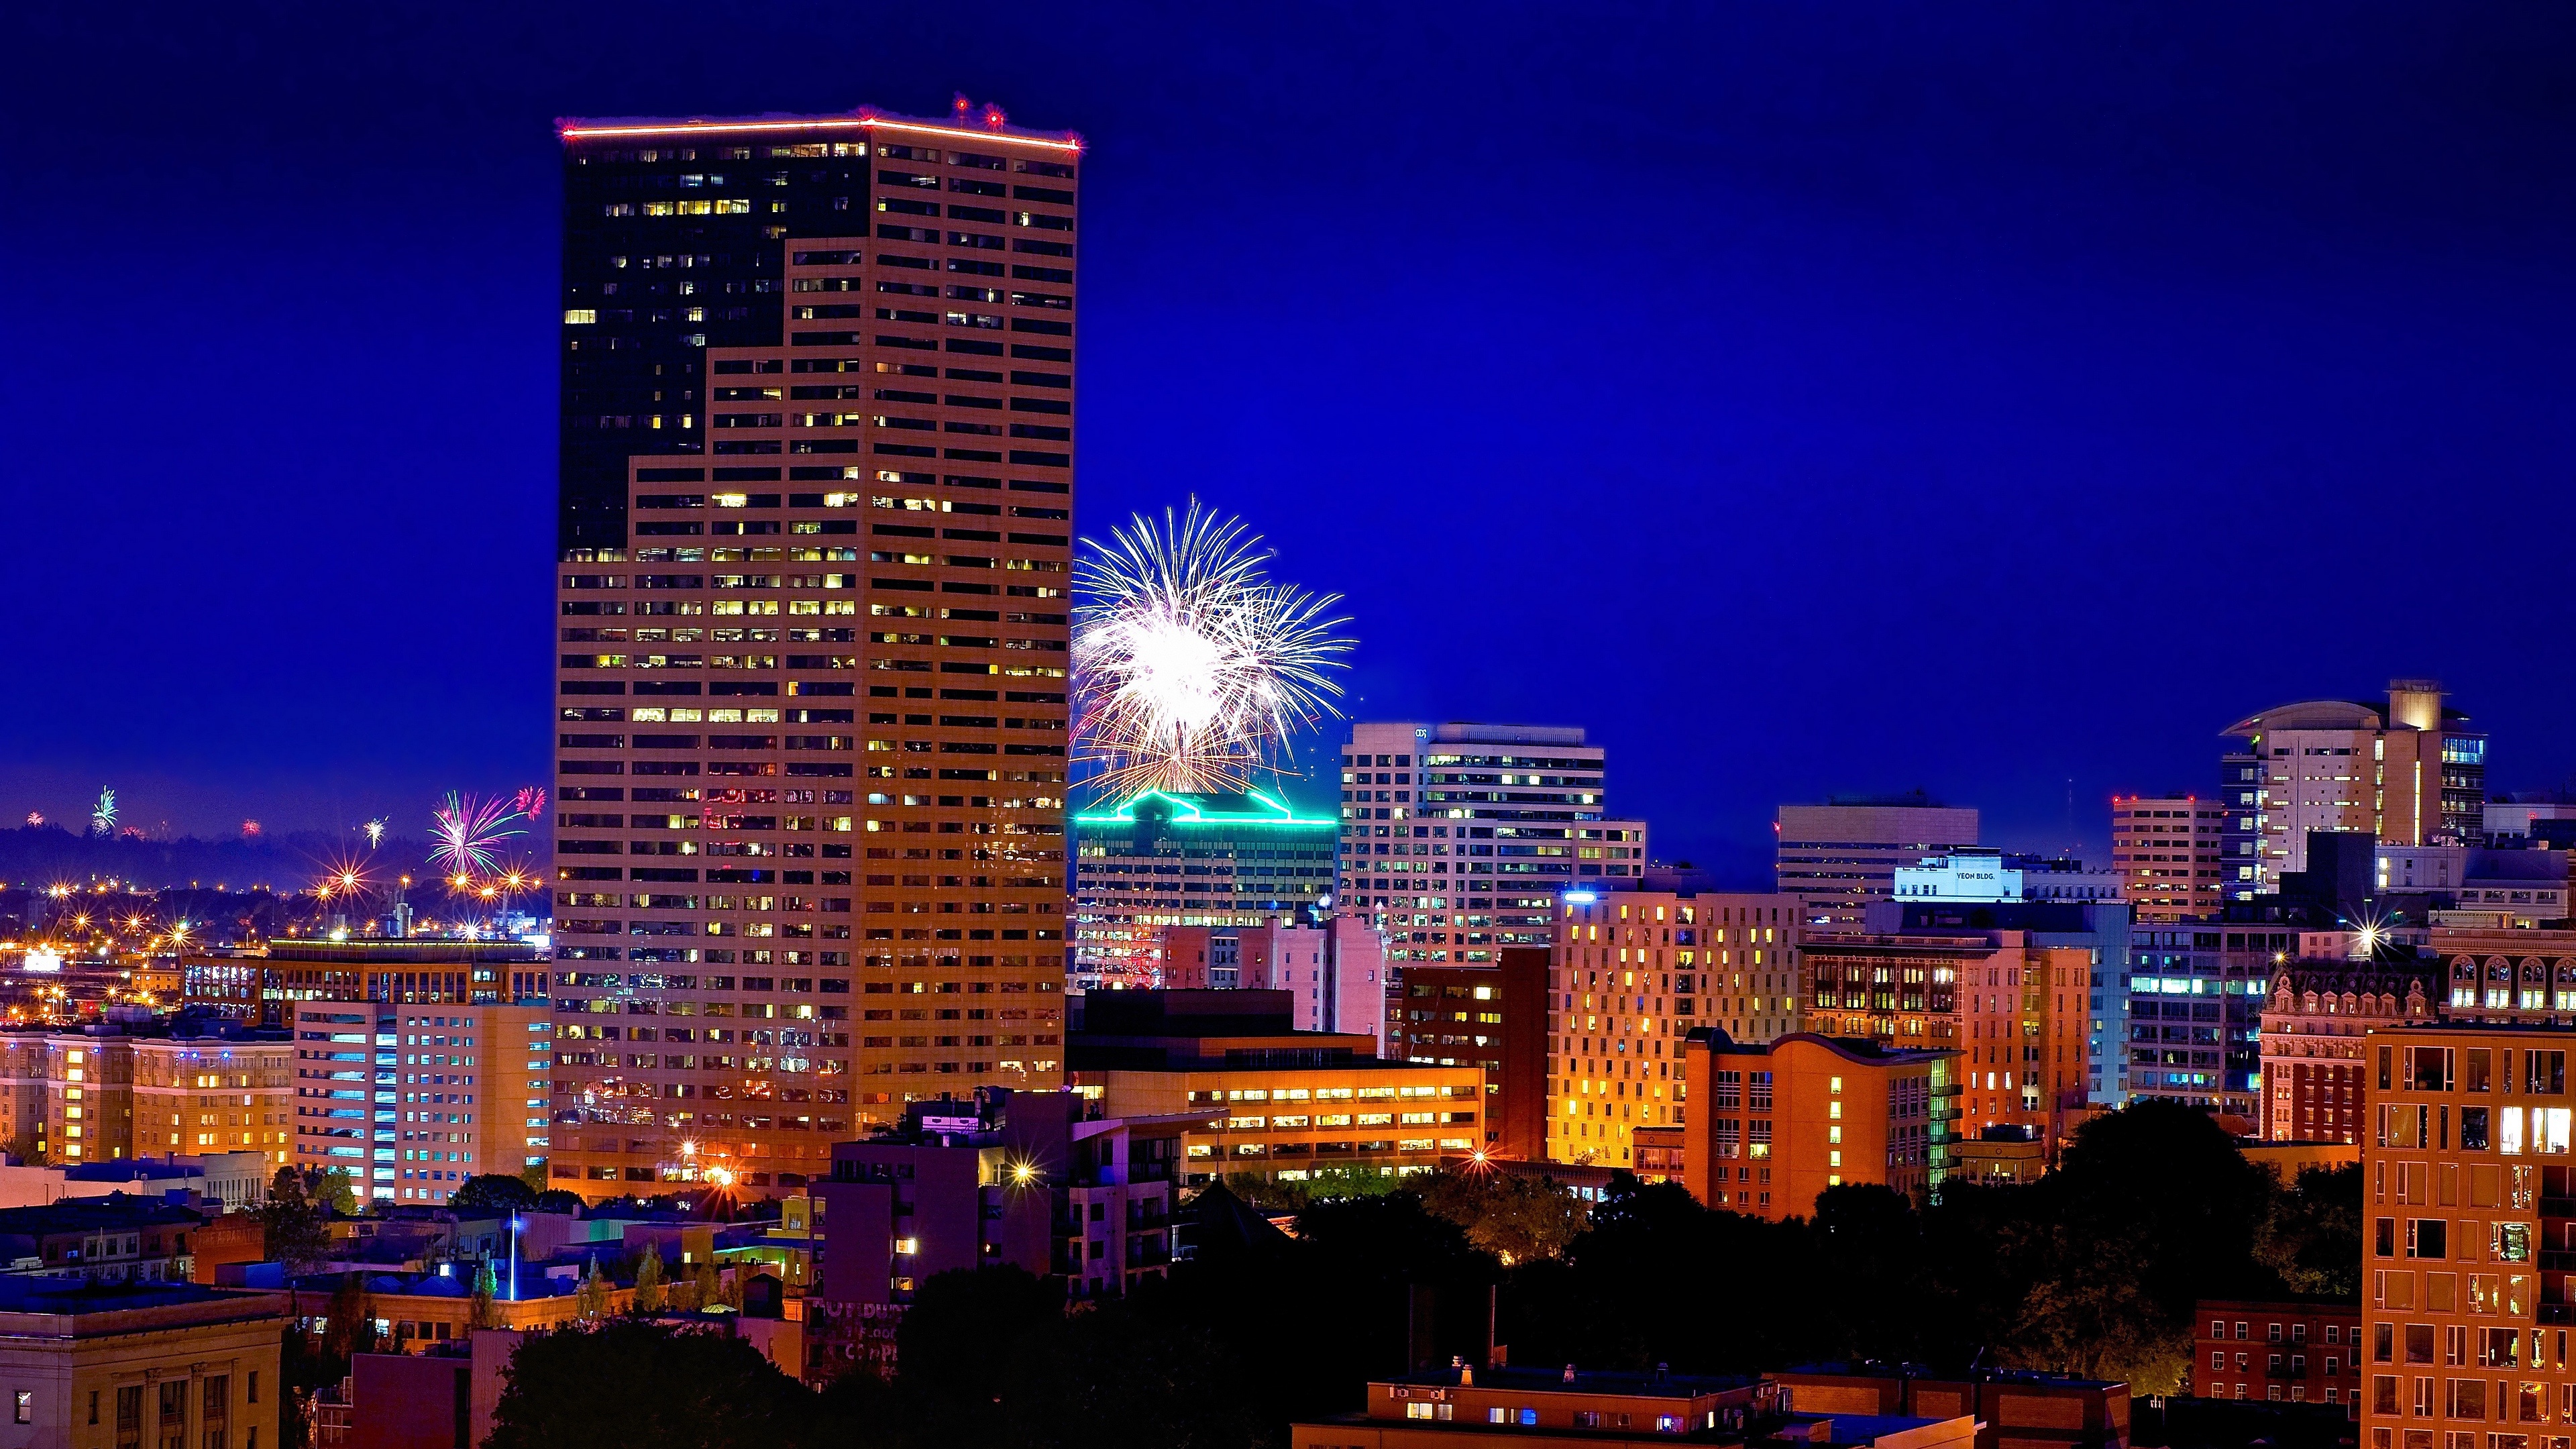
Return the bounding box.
[2220,678,2486,900]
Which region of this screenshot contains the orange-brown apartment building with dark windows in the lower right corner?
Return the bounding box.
[2362,1026,2576,1449]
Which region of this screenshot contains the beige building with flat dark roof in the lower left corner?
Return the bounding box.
[0,1279,286,1449]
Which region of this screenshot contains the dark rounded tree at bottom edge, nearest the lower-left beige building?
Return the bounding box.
[484,1318,814,1449]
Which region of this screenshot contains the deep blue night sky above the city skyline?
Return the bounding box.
[0,3,2576,866]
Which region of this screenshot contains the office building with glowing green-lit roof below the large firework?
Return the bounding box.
[1074,789,1340,990]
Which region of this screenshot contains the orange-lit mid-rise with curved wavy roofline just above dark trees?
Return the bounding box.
[1682,1029,1957,1220]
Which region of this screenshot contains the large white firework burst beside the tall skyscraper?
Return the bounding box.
[1074,498,1350,799]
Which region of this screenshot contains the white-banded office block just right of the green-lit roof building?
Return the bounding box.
[1340,722,1646,969]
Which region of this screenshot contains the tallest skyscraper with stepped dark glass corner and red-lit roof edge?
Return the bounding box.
[551,101,1082,1194]
